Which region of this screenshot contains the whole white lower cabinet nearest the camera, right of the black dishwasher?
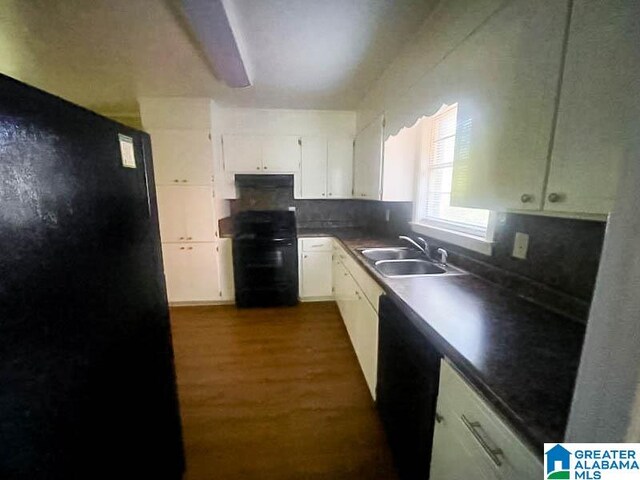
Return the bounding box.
[430,360,543,480]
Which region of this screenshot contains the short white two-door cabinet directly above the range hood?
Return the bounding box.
[222,134,300,173]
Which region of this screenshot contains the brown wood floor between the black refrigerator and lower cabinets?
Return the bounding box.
[171,302,396,480]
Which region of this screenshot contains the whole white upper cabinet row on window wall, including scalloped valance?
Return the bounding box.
[354,0,640,216]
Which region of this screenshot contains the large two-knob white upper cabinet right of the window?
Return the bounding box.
[448,0,640,215]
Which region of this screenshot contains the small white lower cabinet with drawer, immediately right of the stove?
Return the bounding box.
[298,237,333,300]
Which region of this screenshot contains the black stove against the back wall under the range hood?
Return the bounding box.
[233,210,298,307]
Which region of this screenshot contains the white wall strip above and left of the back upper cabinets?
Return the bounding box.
[211,104,356,198]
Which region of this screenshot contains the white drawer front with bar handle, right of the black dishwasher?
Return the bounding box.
[437,360,542,480]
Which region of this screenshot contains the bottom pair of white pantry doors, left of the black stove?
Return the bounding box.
[162,242,220,303]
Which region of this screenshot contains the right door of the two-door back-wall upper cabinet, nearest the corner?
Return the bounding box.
[328,137,353,198]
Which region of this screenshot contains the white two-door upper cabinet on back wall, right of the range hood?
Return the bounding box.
[296,136,353,199]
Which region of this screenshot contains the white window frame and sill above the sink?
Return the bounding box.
[411,103,498,255]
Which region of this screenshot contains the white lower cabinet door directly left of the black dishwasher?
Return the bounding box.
[356,294,378,400]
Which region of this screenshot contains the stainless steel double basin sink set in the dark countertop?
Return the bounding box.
[358,247,465,278]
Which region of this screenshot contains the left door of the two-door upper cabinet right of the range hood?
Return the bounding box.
[300,137,327,199]
